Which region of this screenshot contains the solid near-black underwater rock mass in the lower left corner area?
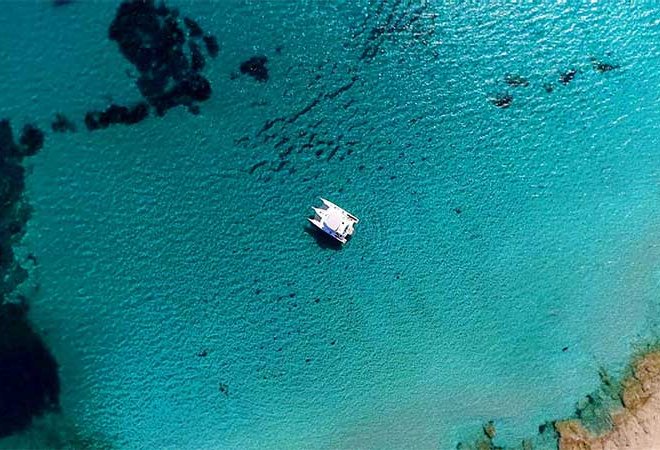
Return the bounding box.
[0,303,60,437]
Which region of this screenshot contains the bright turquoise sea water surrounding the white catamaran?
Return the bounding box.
[0,1,660,449]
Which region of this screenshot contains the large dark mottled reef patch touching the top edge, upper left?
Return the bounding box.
[108,0,219,116]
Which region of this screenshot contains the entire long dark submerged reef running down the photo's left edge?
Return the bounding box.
[0,120,60,437]
